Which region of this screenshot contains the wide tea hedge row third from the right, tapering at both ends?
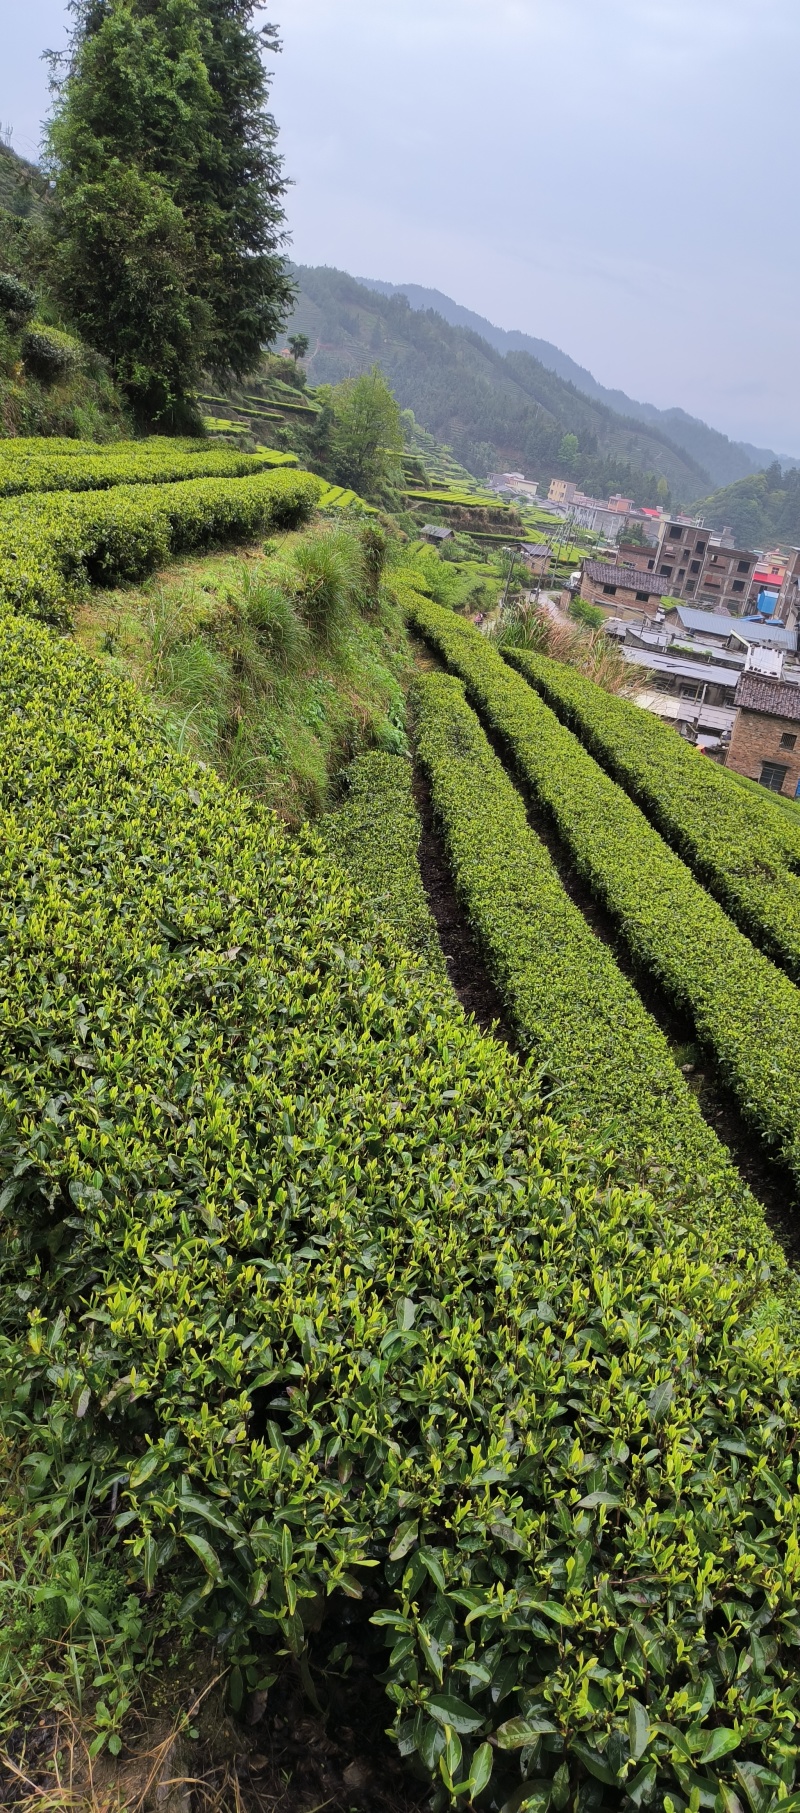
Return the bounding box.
[415,674,785,1269]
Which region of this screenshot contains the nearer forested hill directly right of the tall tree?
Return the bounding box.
[288,265,713,504]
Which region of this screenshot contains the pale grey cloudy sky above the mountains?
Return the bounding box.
[0,0,800,453]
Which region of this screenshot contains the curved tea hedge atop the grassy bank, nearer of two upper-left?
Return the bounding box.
[0,471,323,624]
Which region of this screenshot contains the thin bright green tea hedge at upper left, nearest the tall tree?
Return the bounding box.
[0,439,298,497]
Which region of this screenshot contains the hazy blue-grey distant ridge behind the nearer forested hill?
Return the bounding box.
[359,277,800,486]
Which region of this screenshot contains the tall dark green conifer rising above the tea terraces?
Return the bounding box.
[49,0,292,426]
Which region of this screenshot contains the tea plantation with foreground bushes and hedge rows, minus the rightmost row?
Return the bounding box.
[0,448,800,1813]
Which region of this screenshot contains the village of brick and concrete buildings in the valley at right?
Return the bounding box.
[488,473,800,798]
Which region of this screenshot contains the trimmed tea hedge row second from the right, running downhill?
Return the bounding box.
[412,598,800,1180]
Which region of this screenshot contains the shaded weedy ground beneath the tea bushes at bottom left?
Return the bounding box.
[0,1617,430,1813]
